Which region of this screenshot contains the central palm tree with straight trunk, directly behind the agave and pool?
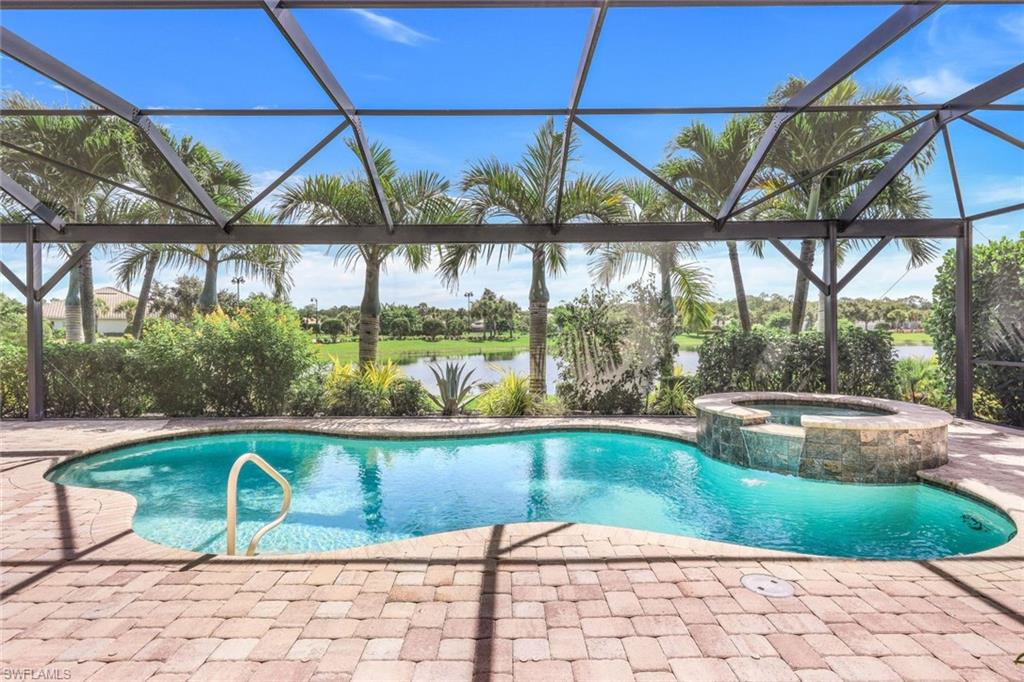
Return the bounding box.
[440,119,627,395]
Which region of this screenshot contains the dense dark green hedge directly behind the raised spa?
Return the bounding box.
[696,325,897,397]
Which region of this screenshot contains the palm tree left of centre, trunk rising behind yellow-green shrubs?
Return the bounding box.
[276,142,465,367]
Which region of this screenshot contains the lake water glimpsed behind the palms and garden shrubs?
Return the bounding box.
[385,346,935,391]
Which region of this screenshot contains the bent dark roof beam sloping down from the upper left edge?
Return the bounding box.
[0,27,227,227]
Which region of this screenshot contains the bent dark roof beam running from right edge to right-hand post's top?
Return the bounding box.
[840,63,1024,226]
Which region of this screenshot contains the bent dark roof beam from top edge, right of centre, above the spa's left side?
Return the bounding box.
[717,2,942,227]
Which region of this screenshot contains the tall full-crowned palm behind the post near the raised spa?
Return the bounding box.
[759,78,938,334]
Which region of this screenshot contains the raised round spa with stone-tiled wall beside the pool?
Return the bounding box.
[696,392,952,483]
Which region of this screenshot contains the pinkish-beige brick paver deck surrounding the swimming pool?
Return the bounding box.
[0,418,1024,682]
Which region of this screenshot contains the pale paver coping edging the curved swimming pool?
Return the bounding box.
[9,417,1024,561]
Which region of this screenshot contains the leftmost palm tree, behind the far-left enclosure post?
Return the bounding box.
[0,93,139,343]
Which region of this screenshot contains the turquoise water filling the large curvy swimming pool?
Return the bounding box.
[49,431,1015,558]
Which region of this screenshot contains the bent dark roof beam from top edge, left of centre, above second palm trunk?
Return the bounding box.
[263,0,394,232]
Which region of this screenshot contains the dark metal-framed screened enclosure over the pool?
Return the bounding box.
[0,0,1024,419]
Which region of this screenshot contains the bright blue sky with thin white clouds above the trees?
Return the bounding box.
[0,5,1024,304]
